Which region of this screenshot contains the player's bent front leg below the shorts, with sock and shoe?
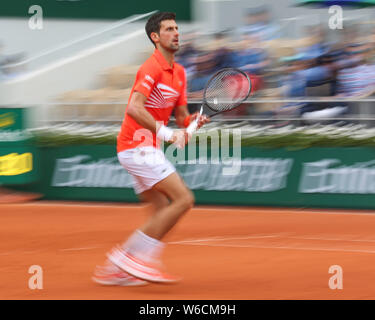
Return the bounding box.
[108,172,194,283]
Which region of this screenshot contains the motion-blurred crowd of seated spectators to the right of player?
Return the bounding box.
[176,7,375,121]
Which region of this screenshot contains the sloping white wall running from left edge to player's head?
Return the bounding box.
[0,29,152,105]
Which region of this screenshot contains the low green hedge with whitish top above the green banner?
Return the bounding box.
[30,125,375,149]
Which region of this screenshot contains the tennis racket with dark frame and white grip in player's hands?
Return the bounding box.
[186,68,251,135]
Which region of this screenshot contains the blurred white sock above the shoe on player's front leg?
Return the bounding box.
[122,230,165,262]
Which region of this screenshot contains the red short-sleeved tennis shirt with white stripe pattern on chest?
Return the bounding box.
[117,49,187,152]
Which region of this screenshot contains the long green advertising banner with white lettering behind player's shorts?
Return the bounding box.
[13,145,375,209]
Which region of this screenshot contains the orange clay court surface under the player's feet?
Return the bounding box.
[0,201,375,300]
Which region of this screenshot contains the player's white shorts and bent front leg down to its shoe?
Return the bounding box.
[108,148,194,282]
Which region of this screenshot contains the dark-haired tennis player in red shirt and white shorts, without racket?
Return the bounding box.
[93,12,209,286]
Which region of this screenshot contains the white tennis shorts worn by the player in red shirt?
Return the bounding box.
[117,147,176,194]
